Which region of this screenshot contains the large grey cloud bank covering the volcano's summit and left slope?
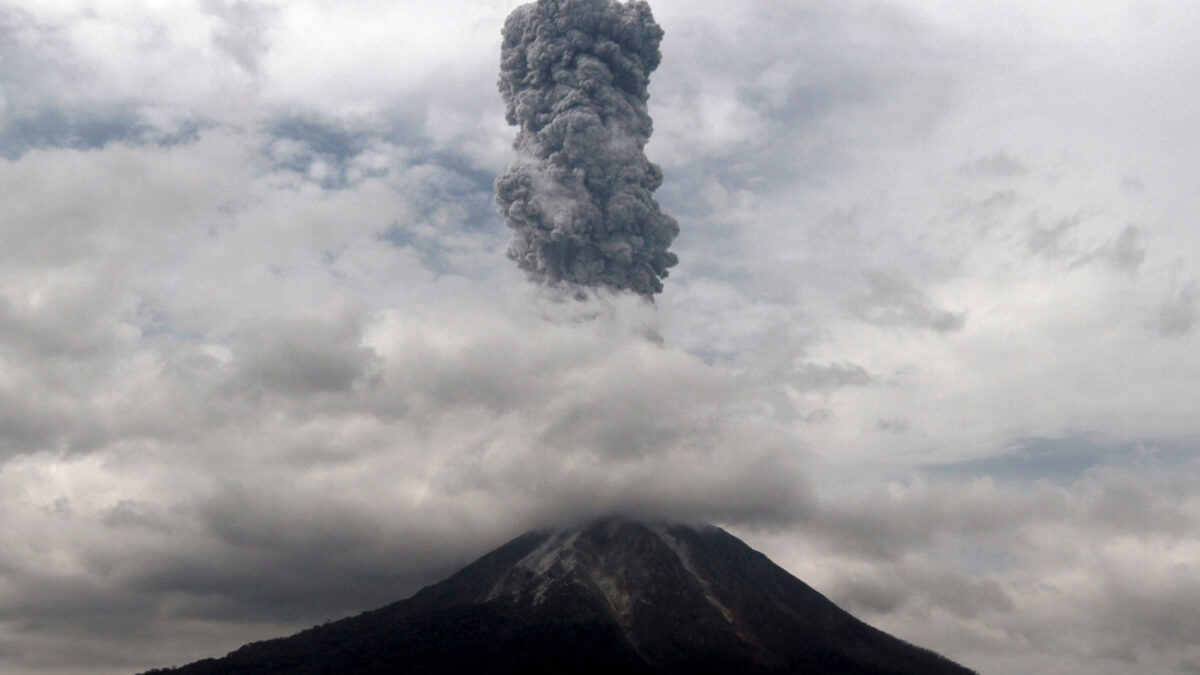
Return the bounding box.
[0,285,810,668]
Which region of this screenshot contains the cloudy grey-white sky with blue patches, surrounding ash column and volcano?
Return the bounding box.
[0,0,1200,675]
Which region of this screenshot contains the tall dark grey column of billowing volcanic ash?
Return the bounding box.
[496,0,679,298]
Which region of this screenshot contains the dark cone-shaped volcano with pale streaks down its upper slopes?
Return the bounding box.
[147,518,972,675]
